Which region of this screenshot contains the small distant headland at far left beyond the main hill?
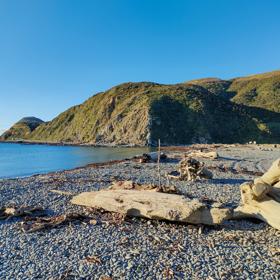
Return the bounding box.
[0,117,44,140]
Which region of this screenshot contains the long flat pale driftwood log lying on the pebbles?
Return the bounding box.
[71,190,231,225]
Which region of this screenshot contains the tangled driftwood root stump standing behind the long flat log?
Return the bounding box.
[167,157,213,181]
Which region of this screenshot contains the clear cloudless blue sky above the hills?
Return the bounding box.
[0,0,280,130]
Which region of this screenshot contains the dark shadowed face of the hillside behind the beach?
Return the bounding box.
[151,87,280,144]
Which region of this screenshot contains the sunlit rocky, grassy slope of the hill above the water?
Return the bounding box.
[30,83,154,145]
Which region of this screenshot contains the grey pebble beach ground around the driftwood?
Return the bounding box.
[0,145,280,280]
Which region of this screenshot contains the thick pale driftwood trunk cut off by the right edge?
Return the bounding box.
[234,159,280,230]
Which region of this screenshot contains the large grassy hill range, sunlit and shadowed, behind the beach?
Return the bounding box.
[1,71,280,145]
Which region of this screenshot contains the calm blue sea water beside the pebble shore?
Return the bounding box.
[0,143,149,178]
